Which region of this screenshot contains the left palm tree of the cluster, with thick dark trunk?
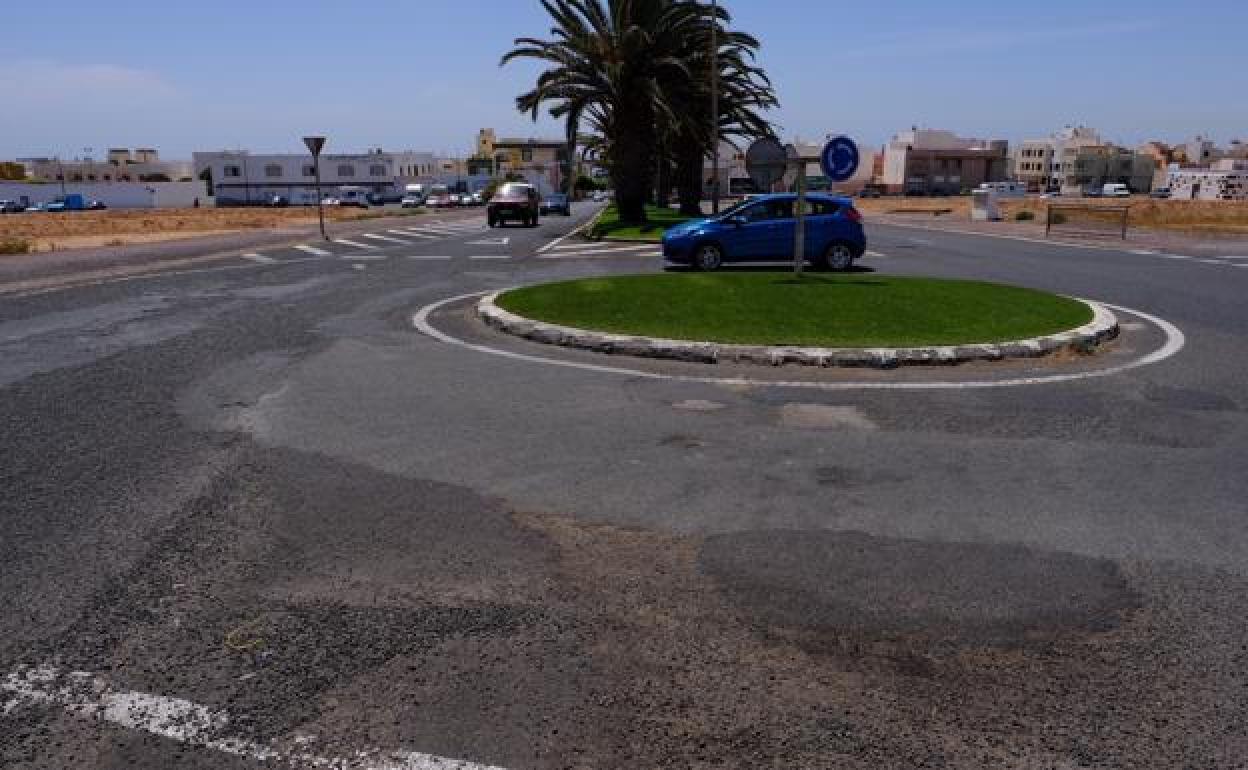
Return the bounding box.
[502,0,703,222]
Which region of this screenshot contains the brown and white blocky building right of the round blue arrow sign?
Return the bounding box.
[884,127,1010,195]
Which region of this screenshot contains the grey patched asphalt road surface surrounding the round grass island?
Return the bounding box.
[0,207,1248,770]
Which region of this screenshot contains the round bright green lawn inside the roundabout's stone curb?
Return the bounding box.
[499,272,1092,347]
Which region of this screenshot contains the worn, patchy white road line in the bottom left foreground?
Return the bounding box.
[0,665,503,770]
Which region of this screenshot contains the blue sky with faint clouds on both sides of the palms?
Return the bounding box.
[0,0,1248,157]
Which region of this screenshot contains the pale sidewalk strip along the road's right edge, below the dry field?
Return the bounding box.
[864,213,1248,257]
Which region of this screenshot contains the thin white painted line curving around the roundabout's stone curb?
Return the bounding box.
[412,292,1187,391]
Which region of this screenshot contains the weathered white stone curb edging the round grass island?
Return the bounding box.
[477,292,1119,369]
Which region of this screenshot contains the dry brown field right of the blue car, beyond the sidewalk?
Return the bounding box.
[855,196,1248,235]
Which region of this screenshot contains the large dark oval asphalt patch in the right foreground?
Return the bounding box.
[699,532,1138,644]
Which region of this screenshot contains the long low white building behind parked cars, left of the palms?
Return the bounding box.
[193,150,466,206]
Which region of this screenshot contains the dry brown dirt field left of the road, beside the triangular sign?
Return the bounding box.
[0,207,394,251]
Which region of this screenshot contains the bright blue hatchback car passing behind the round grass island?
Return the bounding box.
[663,193,866,270]
